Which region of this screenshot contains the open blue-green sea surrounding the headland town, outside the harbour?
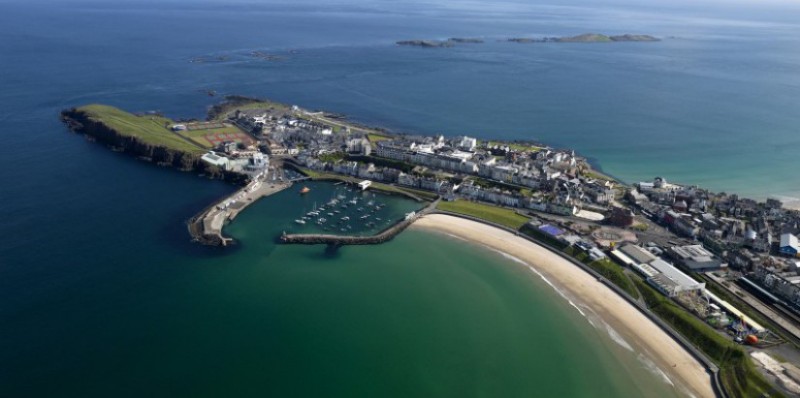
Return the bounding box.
[0,0,800,397]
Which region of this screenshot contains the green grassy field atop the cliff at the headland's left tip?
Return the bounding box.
[78,104,205,153]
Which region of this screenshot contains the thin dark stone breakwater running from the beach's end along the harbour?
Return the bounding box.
[280,198,441,247]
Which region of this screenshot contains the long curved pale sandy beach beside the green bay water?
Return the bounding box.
[412,214,715,397]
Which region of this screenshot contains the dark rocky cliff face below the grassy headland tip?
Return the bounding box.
[60,105,245,183]
